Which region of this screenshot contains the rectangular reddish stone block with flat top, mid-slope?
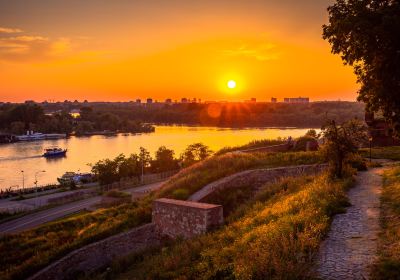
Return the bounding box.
[153,198,224,238]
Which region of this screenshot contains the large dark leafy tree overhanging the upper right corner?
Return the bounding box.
[323,0,400,132]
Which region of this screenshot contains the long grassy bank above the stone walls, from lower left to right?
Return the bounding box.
[0,152,322,279]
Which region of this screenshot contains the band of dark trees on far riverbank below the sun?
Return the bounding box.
[0,101,364,135]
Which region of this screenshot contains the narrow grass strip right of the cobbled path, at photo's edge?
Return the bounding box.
[373,166,400,279]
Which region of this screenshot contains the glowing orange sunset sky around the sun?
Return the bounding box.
[0,0,358,102]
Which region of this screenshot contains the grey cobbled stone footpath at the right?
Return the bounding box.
[317,168,384,279]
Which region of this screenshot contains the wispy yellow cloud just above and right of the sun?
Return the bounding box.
[222,43,279,61]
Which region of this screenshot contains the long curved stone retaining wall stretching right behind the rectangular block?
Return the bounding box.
[189,164,328,202]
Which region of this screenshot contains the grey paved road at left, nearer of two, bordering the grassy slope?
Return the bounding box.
[0,182,164,234]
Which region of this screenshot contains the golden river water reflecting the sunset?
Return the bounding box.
[0,126,307,189]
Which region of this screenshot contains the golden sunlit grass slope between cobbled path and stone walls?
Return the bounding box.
[94,174,353,279]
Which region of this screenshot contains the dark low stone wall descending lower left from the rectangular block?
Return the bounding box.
[29,224,161,280]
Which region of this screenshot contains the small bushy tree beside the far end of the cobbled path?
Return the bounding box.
[322,120,367,178]
